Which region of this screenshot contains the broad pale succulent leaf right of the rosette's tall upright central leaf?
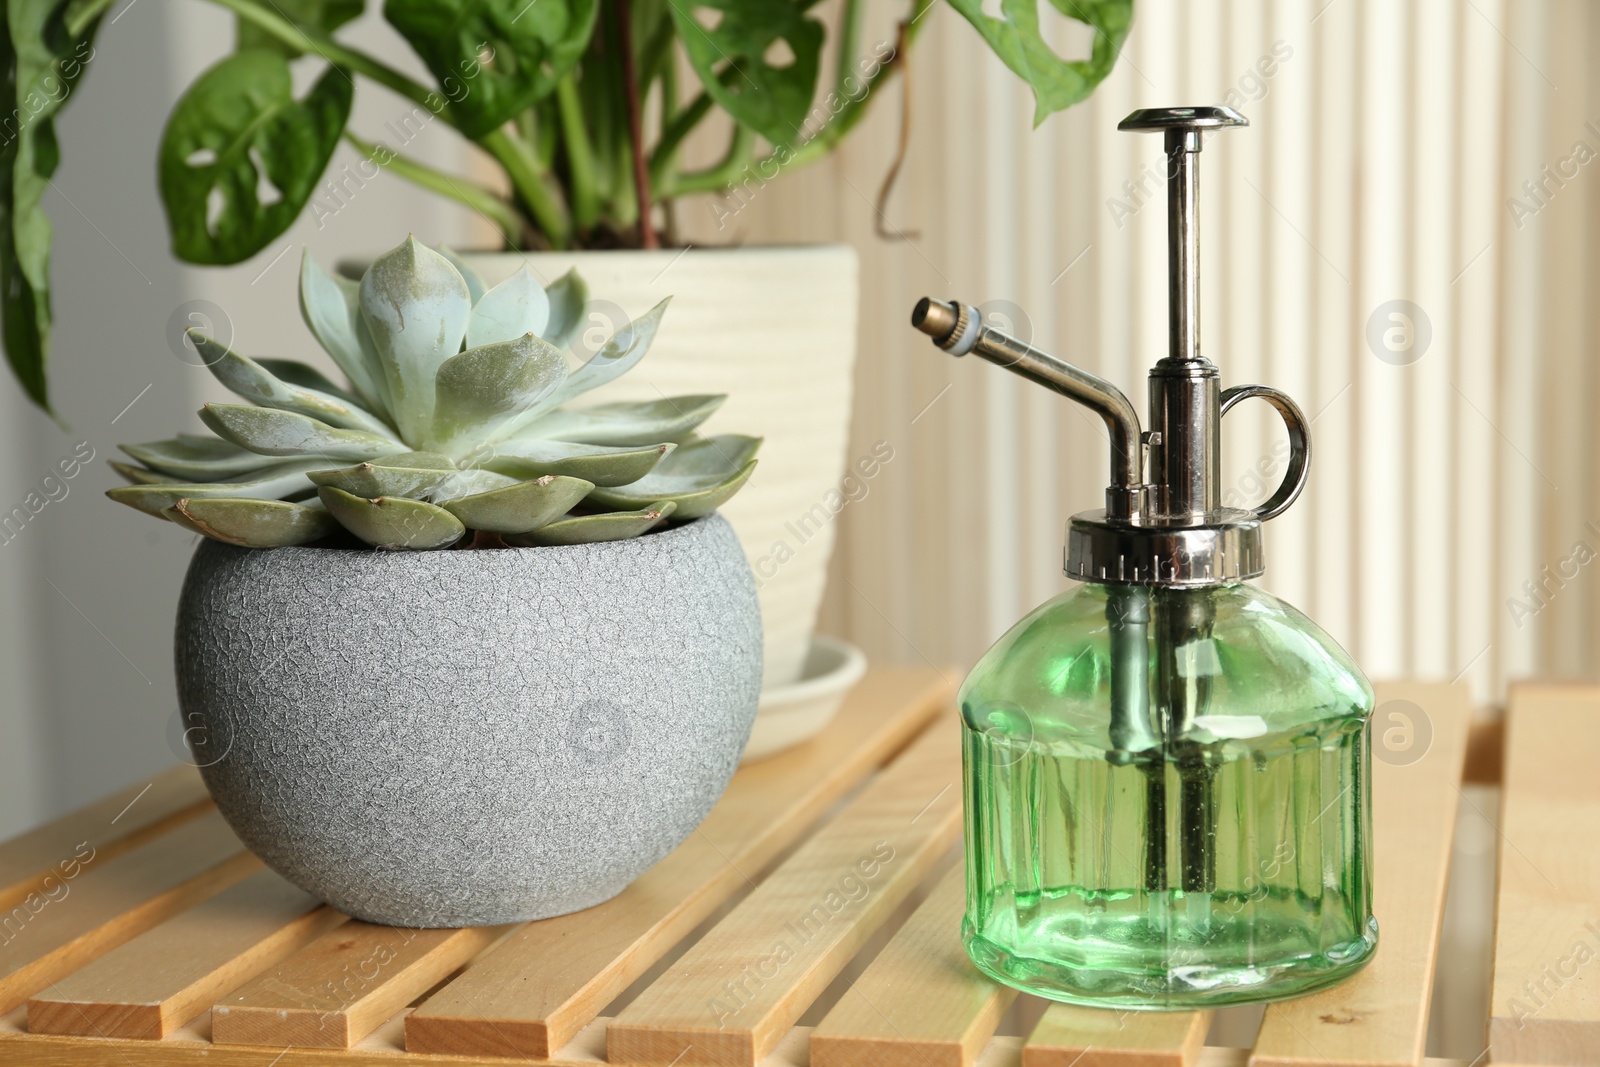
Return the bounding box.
[427,331,566,456]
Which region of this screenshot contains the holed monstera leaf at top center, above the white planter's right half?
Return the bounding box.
[672,0,824,146]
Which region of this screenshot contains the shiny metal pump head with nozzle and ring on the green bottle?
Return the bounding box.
[912,107,1310,587]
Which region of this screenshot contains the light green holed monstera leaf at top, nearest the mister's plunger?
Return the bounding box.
[950,0,1133,126]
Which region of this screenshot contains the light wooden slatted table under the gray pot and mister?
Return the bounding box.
[0,667,1548,1067]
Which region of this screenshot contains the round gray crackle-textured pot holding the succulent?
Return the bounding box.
[178,515,762,926]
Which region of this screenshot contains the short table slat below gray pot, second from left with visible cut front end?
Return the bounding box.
[211,921,510,1048]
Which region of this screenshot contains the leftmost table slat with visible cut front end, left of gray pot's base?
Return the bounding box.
[27,870,344,1040]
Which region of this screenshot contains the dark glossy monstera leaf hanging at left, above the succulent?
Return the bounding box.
[158,50,352,264]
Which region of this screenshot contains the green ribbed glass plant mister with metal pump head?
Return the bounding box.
[912,107,1378,1009]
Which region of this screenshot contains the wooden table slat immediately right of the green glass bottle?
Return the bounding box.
[1250,683,1472,1067]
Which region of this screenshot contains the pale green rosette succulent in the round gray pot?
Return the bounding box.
[107,237,762,549]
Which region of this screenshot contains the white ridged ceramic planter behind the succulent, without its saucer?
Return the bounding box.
[466,245,858,688]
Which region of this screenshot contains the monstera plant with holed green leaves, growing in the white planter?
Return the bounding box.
[0,0,1133,410]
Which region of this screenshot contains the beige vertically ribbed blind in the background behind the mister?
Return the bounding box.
[683,0,1600,699]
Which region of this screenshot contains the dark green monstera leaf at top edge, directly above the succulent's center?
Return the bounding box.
[384,0,600,139]
